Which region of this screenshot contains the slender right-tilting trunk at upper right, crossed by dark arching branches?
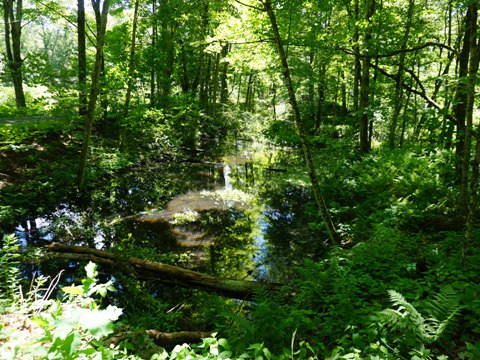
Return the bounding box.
[388,0,415,149]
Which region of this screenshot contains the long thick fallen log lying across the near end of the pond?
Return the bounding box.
[45,243,282,300]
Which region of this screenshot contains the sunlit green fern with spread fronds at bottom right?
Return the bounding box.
[381,288,461,344]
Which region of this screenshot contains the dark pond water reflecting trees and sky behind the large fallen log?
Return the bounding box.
[10,141,323,281]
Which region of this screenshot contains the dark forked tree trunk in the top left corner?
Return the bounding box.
[3,0,27,108]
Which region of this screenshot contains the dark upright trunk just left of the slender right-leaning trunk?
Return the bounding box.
[77,0,87,116]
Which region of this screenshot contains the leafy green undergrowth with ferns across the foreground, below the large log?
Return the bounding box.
[0,226,480,360]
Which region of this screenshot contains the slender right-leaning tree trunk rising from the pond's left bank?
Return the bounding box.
[78,0,110,188]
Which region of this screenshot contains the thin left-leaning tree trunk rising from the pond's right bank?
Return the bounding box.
[262,0,340,244]
